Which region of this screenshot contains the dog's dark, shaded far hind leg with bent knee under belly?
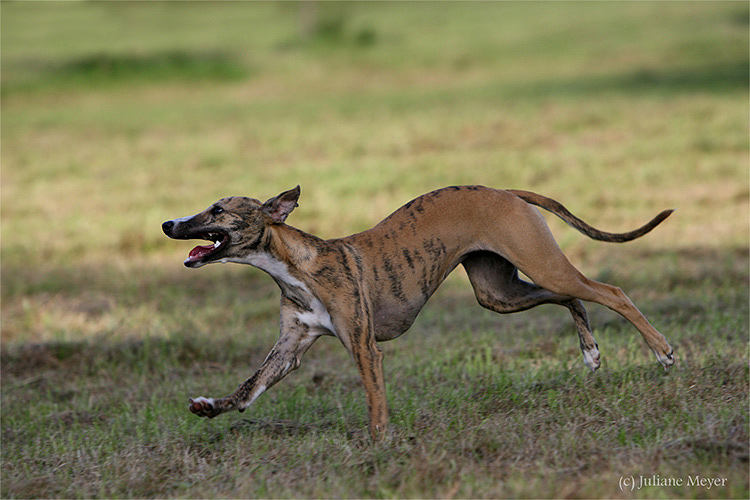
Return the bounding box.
[463,252,601,371]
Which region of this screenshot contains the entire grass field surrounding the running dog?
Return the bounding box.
[0,2,750,498]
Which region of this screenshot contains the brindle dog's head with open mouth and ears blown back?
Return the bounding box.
[161,186,300,267]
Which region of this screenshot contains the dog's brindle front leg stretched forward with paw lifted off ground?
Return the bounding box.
[190,311,317,418]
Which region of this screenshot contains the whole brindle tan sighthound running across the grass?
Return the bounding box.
[162,186,675,440]
